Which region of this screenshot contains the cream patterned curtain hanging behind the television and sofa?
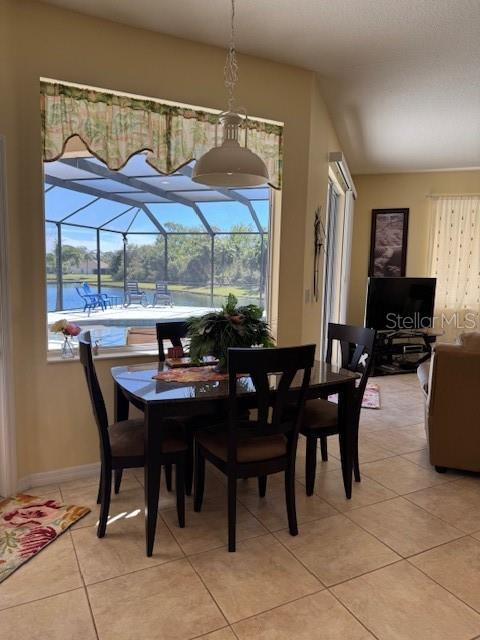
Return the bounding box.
[431,195,480,341]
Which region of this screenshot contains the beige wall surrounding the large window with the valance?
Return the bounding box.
[0,0,337,476]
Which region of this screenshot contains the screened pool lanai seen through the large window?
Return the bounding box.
[44,154,270,344]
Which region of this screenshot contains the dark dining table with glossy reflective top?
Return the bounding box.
[111,361,358,556]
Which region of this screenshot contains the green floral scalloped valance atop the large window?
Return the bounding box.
[40,82,283,189]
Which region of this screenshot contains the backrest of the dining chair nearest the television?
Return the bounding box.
[325,322,376,410]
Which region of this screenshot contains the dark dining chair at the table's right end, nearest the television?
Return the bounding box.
[300,322,376,496]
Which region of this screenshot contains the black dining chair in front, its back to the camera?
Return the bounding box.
[194,345,315,551]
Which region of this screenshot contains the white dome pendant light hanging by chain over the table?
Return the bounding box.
[192,0,269,187]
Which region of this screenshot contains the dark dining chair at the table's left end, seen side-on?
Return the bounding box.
[79,331,187,538]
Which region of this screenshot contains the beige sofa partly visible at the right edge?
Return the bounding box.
[418,333,480,472]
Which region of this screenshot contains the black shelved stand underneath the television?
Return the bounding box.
[372,329,440,376]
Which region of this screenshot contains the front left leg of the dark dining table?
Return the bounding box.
[144,405,161,557]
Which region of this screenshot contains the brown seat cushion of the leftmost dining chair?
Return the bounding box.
[108,418,187,458]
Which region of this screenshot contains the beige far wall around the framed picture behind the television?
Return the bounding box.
[348,171,480,324]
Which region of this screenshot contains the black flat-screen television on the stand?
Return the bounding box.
[365,277,437,331]
